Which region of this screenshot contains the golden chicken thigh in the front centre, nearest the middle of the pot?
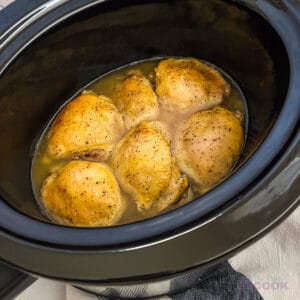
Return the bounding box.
[111,121,188,211]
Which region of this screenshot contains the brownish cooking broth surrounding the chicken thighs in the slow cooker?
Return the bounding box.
[31,58,247,226]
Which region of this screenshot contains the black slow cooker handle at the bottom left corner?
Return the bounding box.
[0,260,36,300]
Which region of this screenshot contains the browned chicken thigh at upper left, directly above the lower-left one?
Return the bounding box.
[48,92,124,161]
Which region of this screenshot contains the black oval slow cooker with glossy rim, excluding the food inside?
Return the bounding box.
[0,0,300,298]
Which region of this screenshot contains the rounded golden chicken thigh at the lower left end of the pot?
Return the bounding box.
[41,161,126,226]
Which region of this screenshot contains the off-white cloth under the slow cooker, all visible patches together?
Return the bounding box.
[0,0,300,300]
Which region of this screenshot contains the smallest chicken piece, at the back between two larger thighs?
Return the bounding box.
[116,74,159,129]
